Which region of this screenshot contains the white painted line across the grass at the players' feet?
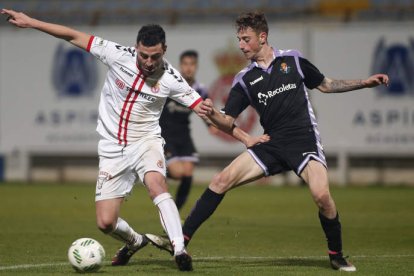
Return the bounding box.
[0,254,414,271]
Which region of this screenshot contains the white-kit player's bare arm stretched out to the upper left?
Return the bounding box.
[0,9,91,50]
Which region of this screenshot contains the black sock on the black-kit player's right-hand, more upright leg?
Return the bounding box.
[319,212,342,255]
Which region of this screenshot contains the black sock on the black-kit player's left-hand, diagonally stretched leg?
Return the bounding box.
[183,188,224,245]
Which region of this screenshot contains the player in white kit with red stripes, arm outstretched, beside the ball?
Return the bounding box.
[1,9,202,270]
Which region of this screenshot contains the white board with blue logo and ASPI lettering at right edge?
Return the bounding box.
[311,26,414,155]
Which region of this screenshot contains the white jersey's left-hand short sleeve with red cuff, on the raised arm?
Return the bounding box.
[86,36,126,66]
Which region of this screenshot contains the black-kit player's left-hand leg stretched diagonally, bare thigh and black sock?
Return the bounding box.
[183,151,264,244]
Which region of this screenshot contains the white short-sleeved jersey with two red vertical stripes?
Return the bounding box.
[87,36,201,145]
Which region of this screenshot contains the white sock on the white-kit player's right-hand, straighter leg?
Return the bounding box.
[153,193,185,255]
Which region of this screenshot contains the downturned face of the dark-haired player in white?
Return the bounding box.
[136,43,165,76]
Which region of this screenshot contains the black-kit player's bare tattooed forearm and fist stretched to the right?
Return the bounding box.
[317,74,389,93]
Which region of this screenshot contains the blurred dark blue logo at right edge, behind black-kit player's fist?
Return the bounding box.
[372,38,414,97]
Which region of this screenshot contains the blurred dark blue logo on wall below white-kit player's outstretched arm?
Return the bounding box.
[52,43,98,97]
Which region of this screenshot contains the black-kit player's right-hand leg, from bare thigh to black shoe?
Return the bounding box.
[301,160,356,271]
